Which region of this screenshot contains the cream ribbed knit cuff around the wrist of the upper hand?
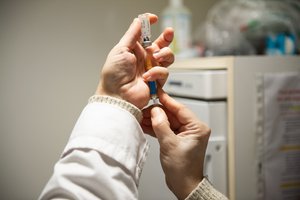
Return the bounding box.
[88,95,143,122]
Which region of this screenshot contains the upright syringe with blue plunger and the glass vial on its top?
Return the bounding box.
[139,14,158,103]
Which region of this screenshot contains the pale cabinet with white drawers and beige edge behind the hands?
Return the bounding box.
[141,56,300,200]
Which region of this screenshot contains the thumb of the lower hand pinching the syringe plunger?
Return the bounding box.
[151,106,175,143]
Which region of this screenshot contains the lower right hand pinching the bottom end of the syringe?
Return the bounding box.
[142,90,210,199]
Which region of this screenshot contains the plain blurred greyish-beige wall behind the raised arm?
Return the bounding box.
[0,0,217,200]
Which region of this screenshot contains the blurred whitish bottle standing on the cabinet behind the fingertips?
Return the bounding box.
[161,0,191,54]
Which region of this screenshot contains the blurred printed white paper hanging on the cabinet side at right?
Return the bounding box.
[256,73,300,200]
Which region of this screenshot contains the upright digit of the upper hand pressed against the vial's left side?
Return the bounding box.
[118,18,141,50]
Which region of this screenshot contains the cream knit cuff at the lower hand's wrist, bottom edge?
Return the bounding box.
[185,177,227,200]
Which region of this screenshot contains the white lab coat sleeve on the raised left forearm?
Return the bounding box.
[39,102,149,199]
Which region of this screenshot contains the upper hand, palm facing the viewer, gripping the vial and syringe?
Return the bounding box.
[96,14,174,109]
